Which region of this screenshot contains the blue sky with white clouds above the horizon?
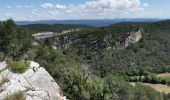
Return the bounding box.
[0,0,170,21]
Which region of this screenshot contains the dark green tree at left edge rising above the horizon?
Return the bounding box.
[0,19,32,58]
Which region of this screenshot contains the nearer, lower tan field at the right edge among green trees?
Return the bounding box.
[130,82,170,94]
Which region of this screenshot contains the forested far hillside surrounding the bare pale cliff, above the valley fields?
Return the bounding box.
[49,21,170,74]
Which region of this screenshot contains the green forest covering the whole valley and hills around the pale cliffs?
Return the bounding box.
[0,19,170,100]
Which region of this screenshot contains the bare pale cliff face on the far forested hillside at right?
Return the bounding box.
[114,29,143,50]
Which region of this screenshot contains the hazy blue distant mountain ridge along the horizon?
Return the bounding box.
[16,18,161,27]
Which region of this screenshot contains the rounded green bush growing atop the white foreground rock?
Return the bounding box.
[8,60,29,73]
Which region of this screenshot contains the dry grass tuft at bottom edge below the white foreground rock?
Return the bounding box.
[4,92,25,100]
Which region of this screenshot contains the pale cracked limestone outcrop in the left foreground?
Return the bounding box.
[0,61,66,100]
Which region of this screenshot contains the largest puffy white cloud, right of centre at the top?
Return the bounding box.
[61,0,143,18]
